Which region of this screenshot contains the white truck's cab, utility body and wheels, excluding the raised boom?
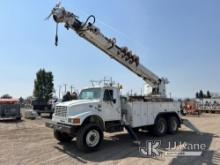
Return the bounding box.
[46,85,182,151]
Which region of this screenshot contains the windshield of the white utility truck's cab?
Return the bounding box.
[79,88,101,100]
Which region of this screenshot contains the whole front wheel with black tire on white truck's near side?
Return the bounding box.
[76,123,103,152]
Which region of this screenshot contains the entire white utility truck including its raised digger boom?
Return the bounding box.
[46,4,197,151]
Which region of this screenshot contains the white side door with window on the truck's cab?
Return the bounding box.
[102,89,121,121]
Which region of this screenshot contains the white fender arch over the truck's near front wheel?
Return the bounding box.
[69,111,102,126]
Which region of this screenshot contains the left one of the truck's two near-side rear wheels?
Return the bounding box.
[152,117,167,137]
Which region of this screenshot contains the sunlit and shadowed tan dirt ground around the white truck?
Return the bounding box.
[0,111,220,165]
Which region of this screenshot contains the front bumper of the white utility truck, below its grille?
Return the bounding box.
[45,121,77,134]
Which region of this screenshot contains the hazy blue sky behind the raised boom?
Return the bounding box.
[0,0,220,97]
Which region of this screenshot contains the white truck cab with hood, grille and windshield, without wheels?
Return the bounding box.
[52,86,121,126]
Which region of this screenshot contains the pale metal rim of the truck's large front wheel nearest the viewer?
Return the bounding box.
[86,130,100,147]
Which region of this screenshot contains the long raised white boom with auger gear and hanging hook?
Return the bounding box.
[51,5,168,97]
